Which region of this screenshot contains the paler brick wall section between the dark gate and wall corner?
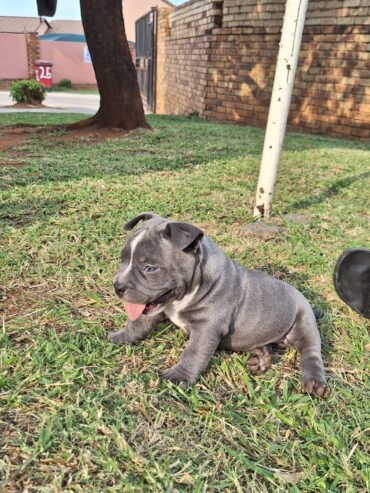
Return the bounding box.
[157,0,217,114]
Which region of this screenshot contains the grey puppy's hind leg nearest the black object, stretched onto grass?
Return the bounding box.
[282,305,330,398]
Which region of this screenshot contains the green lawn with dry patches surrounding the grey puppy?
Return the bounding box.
[0,113,370,493]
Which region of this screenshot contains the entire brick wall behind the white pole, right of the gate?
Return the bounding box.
[157,0,370,139]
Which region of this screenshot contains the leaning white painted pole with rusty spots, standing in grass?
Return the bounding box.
[253,0,308,218]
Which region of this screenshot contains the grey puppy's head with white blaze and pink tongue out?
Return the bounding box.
[114,212,203,320]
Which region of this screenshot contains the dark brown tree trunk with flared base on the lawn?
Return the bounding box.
[77,0,150,130]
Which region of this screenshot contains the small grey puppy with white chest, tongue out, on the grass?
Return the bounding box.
[109,212,330,397]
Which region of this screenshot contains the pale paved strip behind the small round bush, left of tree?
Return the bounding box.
[0,91,100,114]
